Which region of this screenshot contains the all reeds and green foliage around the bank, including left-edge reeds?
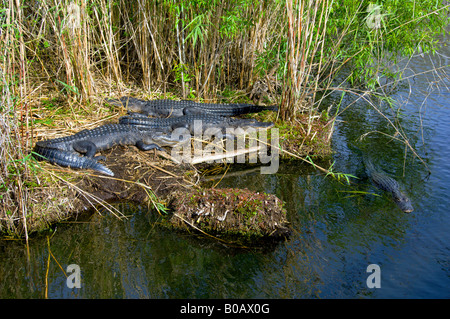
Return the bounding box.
[0,0,448,239]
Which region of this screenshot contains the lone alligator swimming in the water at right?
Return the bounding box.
[363,155,414,213]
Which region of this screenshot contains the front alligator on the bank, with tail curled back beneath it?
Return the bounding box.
[33,124,190,176]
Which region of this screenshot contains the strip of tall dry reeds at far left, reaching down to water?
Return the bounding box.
[0,1,30,240]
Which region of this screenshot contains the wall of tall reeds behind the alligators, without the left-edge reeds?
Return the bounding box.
[7,0,448,109]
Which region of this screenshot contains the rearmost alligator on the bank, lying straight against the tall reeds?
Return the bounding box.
[106,96,278,117]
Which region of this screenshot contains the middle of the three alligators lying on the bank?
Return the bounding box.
[119,113,273,134]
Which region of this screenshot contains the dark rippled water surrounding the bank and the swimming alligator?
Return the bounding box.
[0,47,450,298]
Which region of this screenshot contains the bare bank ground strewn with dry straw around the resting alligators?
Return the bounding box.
[1,96,331,238]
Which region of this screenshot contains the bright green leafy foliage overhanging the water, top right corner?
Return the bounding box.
[325,0,449,88]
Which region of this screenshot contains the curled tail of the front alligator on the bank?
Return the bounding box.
[33,145,114,176]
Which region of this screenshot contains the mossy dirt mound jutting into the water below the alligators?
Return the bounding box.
[169,188,290,239]
